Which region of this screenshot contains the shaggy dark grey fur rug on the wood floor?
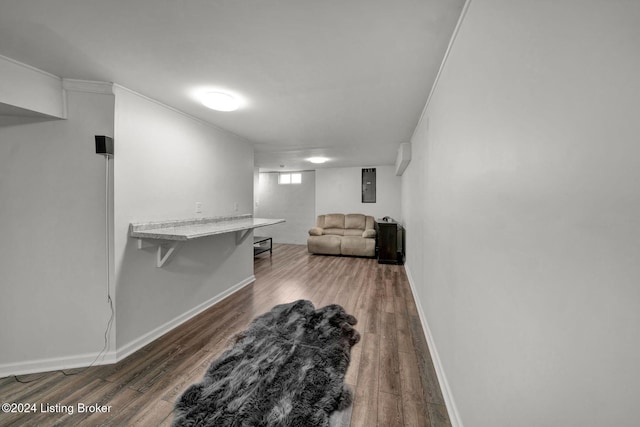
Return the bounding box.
[173,300,360,427]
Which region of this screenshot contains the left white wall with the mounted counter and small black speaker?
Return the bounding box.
[0,77,254,376]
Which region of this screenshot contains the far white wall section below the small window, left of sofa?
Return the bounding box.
[255,171,316,245]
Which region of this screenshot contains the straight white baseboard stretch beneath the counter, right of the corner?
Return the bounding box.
[116,275,256,362]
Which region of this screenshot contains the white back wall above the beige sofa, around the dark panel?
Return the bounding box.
[314,165,401,223]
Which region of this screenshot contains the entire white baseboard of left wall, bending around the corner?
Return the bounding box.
[0,275,256,378]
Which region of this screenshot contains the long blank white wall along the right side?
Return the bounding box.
[402,0,640,427]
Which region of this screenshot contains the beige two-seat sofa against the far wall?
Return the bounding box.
[307,214,376,257]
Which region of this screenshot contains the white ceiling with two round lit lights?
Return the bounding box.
[0,0,464,170]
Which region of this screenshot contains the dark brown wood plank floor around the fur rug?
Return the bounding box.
[0,244,450,427]
